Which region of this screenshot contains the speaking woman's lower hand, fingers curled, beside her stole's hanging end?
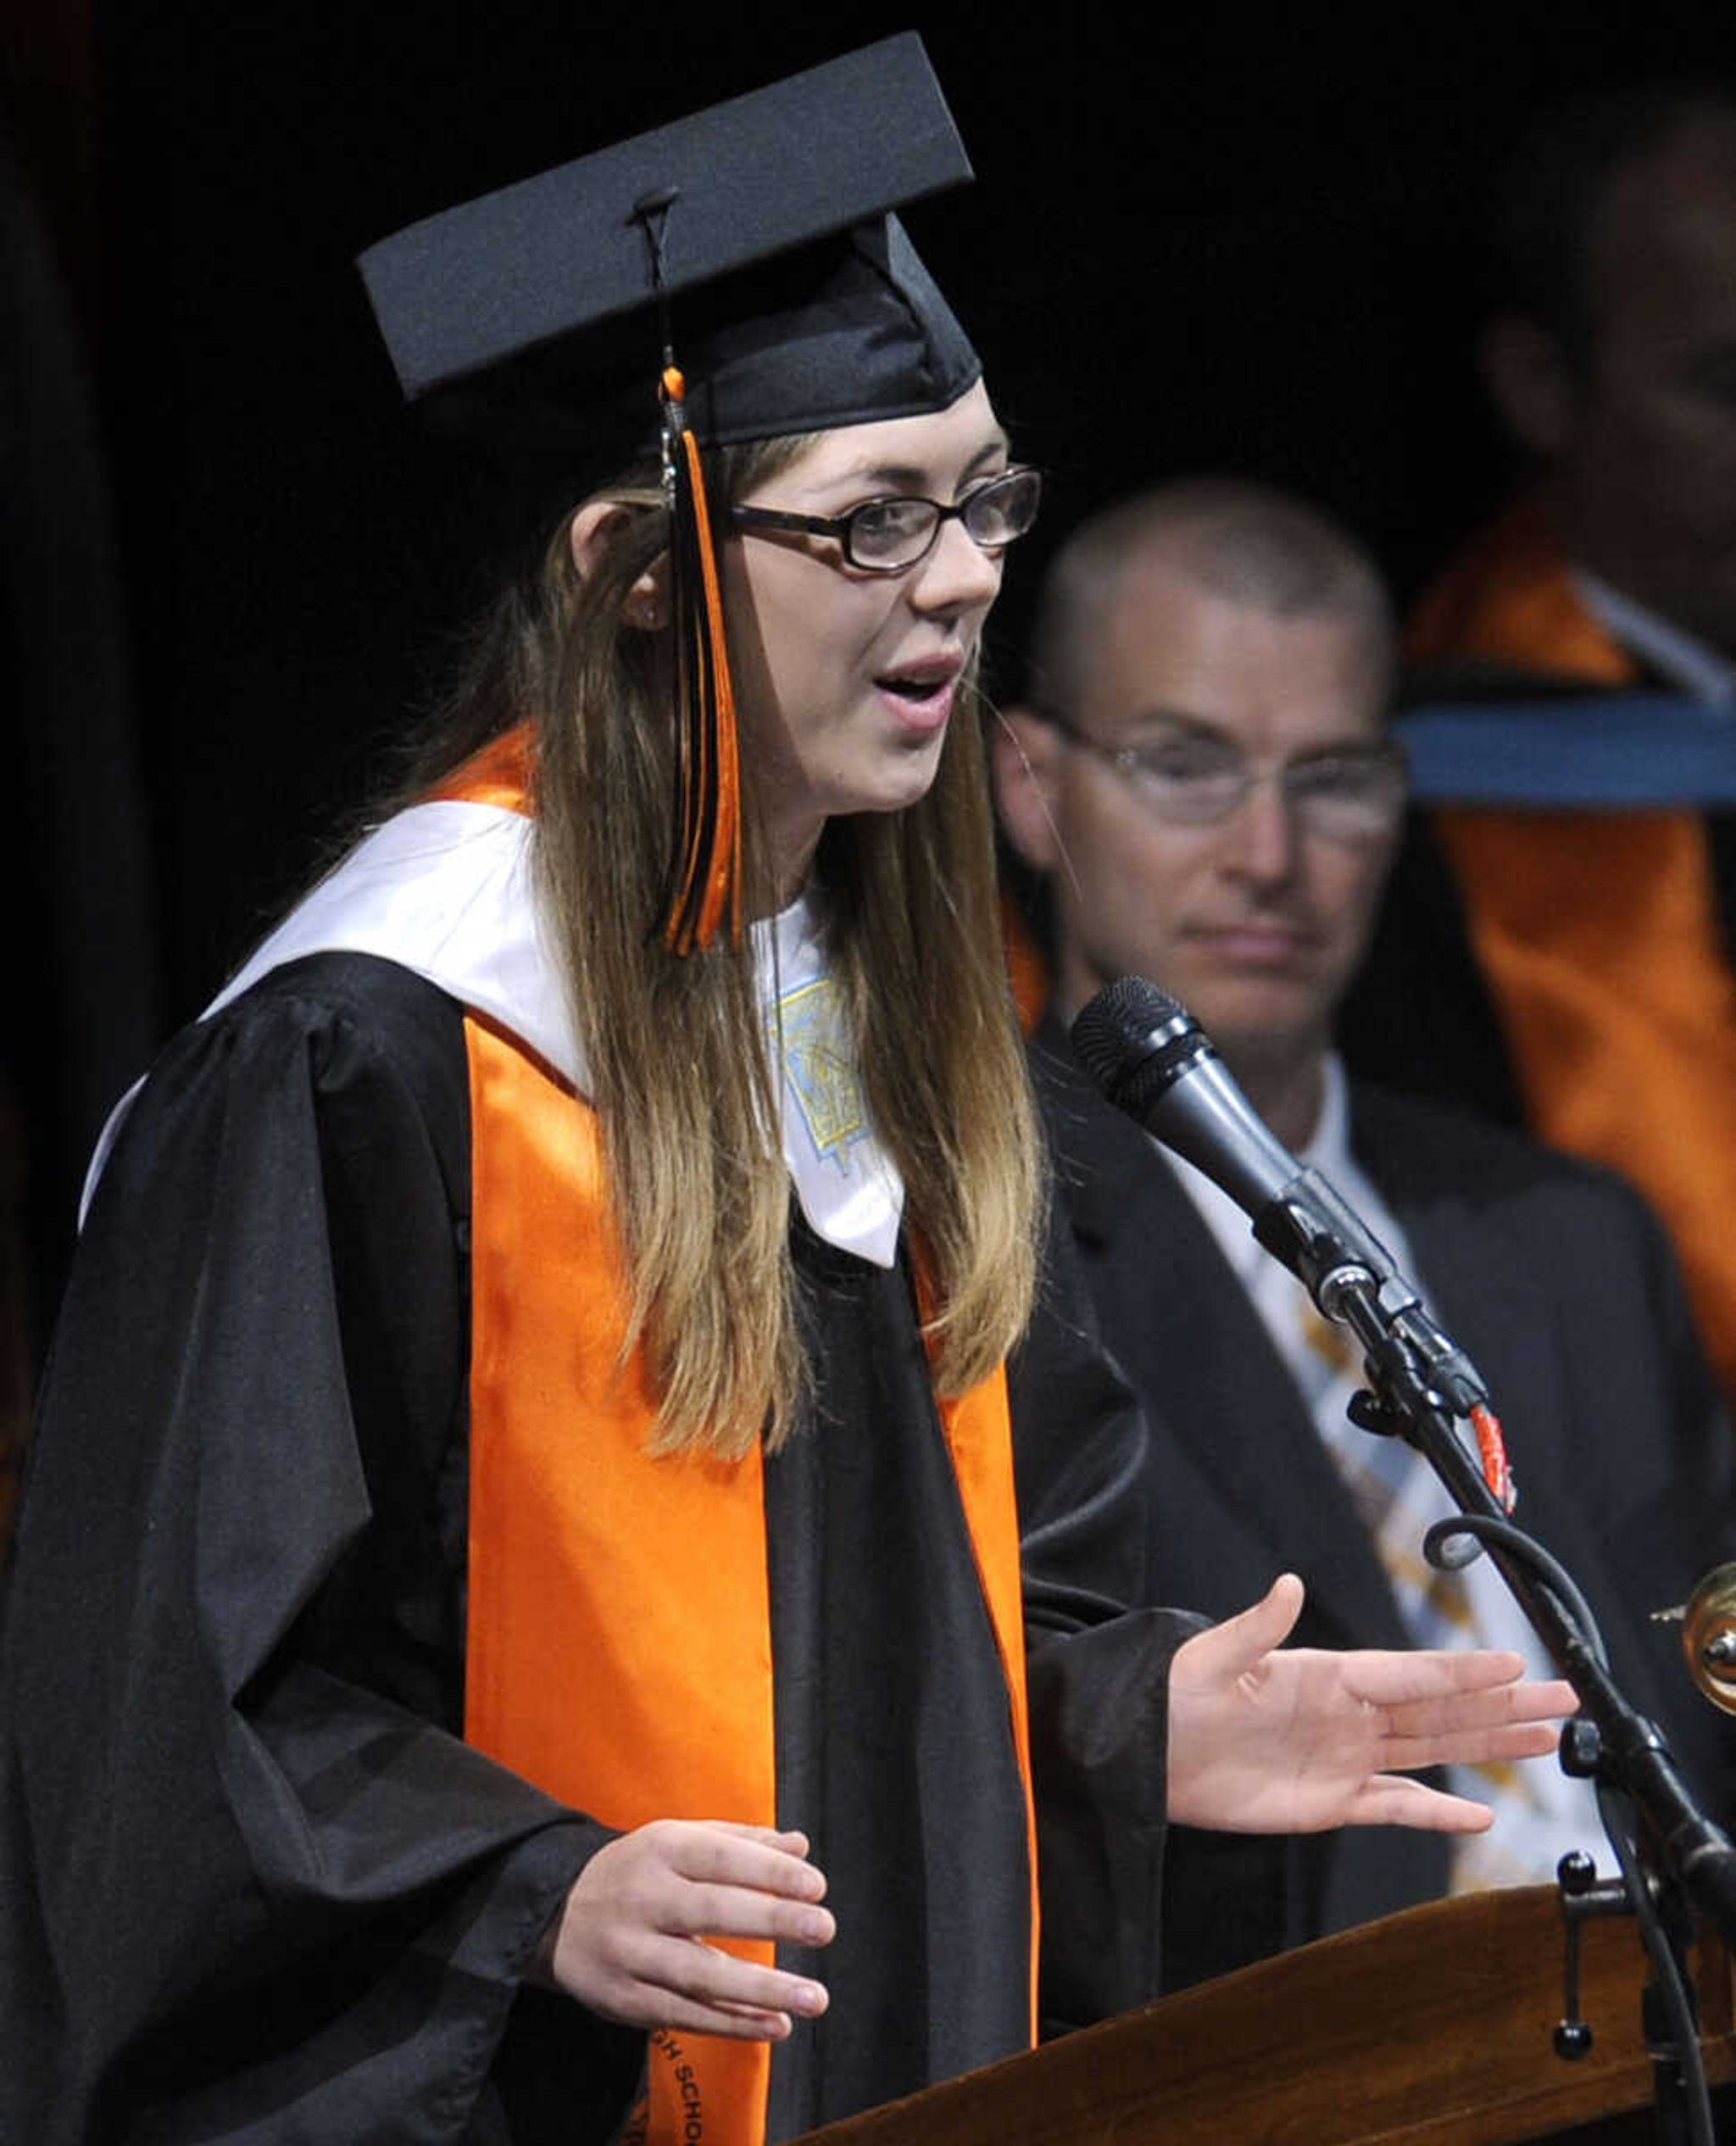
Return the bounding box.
[537,1818,837,2041]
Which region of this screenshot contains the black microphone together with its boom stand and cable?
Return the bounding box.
[1073,977,1736,2146]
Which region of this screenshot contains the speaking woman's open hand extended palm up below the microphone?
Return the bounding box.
[1170,1573,1579,1832]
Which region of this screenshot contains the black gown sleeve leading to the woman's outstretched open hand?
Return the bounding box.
[1009,1217,1206,2037]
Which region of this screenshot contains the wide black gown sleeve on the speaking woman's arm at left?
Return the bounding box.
[0,957,639,2146]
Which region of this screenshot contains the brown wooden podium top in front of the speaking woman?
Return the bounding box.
[803,1887,1736,2146]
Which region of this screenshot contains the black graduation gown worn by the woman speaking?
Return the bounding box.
[0,955,1188,2146]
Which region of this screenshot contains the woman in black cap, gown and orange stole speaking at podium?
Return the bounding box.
[0,39,1560,2146]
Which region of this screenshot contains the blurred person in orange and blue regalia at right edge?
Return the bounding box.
[1344,88,1736,1397]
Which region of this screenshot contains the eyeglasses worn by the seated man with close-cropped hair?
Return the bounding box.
[1043,708,1405,841]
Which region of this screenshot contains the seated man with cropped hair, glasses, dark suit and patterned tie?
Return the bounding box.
[996,481,1736,1987]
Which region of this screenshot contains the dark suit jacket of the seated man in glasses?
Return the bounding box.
[1034,1022,1736,1987]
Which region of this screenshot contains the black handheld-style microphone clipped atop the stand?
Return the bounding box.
[1073,977,1489,1416]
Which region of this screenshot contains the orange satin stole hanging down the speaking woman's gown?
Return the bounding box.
[442,740,1037,2146]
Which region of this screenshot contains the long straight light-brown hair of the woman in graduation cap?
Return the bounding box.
[419,438,1043,1455]
